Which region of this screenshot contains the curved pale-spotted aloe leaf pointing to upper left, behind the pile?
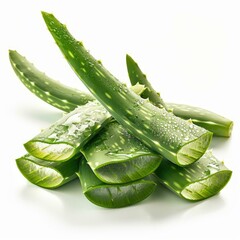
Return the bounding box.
[9,50,94,112]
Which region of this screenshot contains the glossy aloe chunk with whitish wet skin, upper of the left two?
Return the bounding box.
[24,101,111,161]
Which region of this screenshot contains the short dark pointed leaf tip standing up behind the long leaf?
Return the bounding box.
[126,54,168,109]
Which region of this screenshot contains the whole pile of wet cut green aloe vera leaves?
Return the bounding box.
[9,12,233,208]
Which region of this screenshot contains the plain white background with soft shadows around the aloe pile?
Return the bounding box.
[0,0,240,240]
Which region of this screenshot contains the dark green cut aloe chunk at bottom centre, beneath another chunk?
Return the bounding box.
[77,159,156,208]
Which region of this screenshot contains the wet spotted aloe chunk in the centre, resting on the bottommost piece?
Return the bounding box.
[81,121,162,184]
